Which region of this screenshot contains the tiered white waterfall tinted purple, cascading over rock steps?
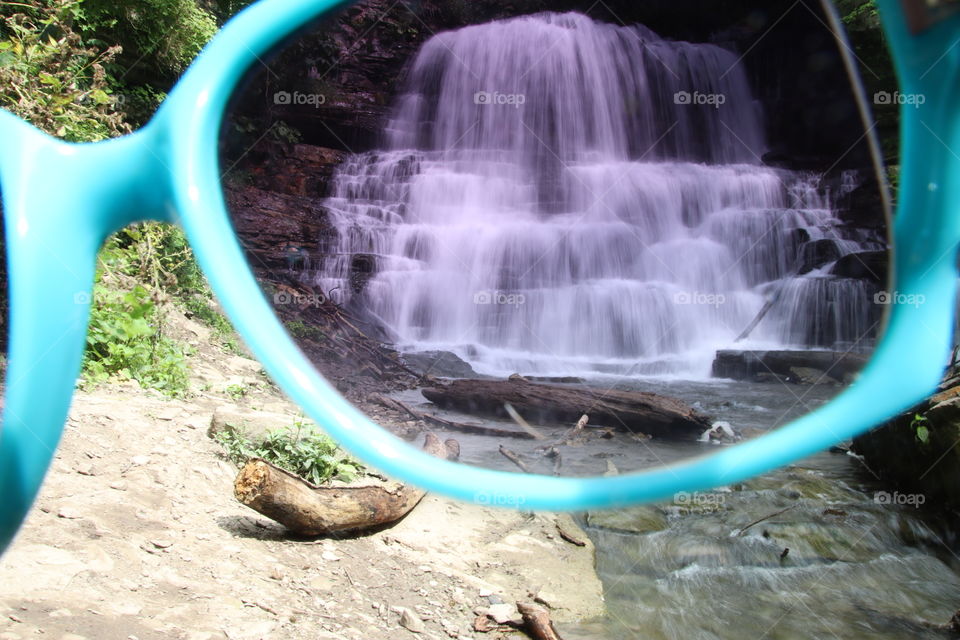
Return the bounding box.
[316,13,881,376]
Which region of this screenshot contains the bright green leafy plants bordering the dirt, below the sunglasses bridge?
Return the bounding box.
[84,284,188,396]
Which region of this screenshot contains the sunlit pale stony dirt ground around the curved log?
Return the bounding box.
[0,312,603,640]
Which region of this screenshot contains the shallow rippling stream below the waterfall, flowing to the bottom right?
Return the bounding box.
[398,380,960,640]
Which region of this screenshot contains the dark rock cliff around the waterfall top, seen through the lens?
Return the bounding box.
[225,0,884,280]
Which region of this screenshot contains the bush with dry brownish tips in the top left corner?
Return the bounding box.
[0,0,129,142]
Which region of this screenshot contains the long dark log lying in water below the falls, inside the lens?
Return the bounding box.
[422,379,710,440]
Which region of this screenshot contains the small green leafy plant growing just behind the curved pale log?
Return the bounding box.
[216,421,364,485]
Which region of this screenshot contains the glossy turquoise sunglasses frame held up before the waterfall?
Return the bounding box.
[0,0,960,550]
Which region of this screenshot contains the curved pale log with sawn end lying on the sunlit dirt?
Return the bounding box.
[234,434,460,536]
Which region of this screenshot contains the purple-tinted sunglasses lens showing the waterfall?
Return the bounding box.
[222,2,895,475]
